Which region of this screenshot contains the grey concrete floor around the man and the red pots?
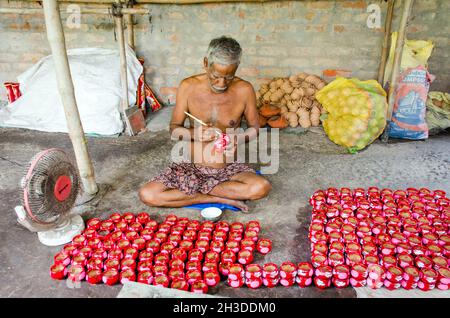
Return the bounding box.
[0,121,450,297]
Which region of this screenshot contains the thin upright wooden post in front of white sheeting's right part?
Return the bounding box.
[113,0,133,136]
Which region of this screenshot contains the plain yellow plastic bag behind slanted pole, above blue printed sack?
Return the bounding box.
[384,32,434,84]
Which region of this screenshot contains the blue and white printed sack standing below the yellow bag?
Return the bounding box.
[389,66,433,140]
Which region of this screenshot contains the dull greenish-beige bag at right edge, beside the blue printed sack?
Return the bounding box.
[426,92,450,134]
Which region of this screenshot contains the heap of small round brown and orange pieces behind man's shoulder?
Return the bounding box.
[256,72,326,128]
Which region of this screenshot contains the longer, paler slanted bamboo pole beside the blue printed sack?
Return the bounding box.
[381,0,414,142]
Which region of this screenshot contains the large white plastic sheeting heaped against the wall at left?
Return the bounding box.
[0,47,143,135]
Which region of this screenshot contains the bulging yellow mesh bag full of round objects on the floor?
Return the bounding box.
[316,77,387,153]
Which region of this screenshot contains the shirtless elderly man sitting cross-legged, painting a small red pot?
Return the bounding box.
[139,37,271,212]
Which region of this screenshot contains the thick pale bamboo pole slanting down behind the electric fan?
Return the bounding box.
[44,0,98,195]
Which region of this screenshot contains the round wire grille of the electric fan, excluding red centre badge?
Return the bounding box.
[21,149,80,224]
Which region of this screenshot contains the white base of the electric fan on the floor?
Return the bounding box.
[38,214,84,246]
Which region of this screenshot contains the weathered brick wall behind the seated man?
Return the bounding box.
[0,0,450,104]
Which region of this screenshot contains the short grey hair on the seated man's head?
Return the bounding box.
[206,36,242,66]
